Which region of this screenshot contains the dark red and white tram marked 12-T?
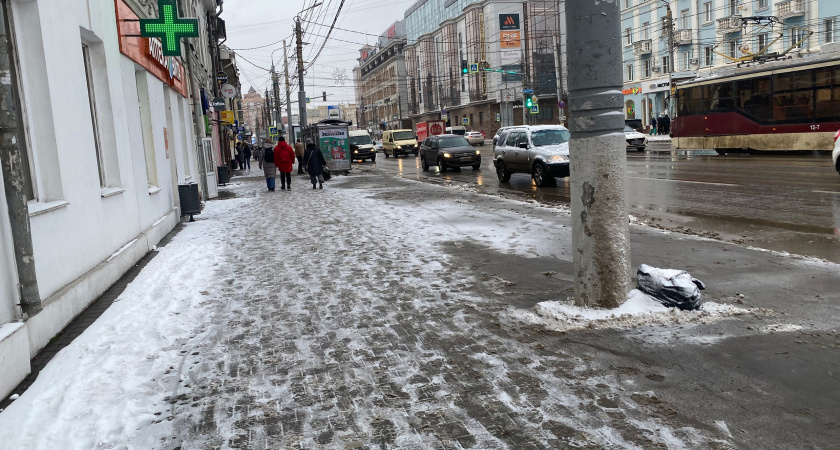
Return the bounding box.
[671,57,840,154]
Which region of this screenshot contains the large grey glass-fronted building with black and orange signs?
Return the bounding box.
[404,0,566,134]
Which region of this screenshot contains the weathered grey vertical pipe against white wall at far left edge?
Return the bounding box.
[0,2,41,316]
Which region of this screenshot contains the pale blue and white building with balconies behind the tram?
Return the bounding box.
[621,0,840,124]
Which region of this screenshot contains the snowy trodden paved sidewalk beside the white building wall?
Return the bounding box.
[0,171,840,449]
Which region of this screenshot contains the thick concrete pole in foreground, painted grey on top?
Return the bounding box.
[566,0,630,308]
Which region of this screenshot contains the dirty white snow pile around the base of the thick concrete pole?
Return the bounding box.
[517,289,752,331]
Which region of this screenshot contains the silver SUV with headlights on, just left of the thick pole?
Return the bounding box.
[493,125,570,187]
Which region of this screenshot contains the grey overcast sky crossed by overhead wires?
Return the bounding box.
[222,0,416,106]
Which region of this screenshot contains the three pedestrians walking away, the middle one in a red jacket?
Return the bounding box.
[257,136,327,192]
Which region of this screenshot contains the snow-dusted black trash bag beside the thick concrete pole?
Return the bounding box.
[636,264,706,311]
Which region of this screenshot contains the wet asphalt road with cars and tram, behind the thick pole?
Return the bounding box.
[355,143,840,263]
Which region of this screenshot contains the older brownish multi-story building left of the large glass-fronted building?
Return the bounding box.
[353,20,411,134]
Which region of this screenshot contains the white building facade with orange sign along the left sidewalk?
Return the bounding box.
[0,0,216,396]
